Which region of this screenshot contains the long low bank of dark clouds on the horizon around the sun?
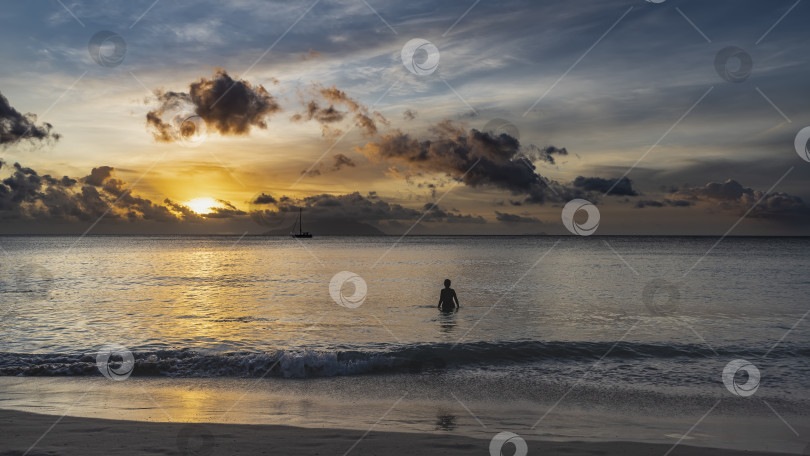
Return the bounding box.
[0,158,486,234]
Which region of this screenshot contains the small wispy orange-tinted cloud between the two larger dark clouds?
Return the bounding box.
[291,84,389,136]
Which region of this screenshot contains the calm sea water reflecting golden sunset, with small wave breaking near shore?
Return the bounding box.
[0,236,810,448]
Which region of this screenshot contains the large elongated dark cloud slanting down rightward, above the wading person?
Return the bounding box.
[360,120,636,204]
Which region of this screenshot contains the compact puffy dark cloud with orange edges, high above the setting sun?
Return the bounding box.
[146,68,281,142]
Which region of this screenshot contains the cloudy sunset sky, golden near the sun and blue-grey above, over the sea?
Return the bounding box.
[0,0,810,235]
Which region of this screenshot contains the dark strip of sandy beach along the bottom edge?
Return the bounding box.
[0,410,788,456]
